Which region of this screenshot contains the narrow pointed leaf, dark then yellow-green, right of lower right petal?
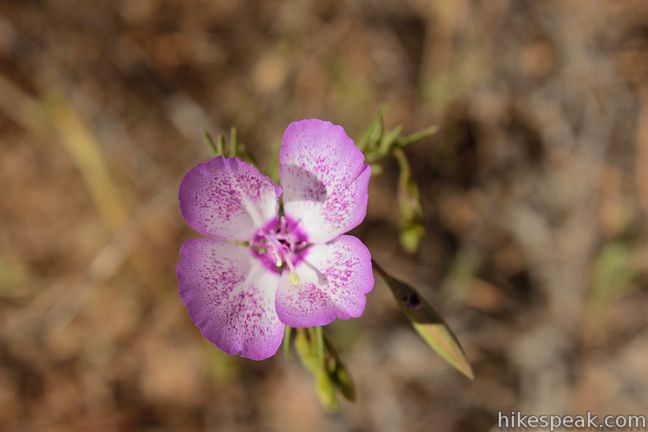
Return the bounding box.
[372,260,474,379]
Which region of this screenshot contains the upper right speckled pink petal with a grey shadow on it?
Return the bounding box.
[280,119,371,243]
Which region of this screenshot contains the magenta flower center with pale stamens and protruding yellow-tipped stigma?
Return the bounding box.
[250,216,309,285]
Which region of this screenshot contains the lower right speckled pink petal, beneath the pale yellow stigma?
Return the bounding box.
[277,235,374,327]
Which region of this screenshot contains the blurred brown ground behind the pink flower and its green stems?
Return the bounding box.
[0,0,648,432]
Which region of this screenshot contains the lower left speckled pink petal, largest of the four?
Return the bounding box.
[176,238,284,360]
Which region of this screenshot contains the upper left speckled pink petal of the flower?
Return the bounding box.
[178,156,281,241]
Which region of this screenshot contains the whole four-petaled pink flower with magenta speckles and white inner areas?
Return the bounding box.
[176,119,374,360]
